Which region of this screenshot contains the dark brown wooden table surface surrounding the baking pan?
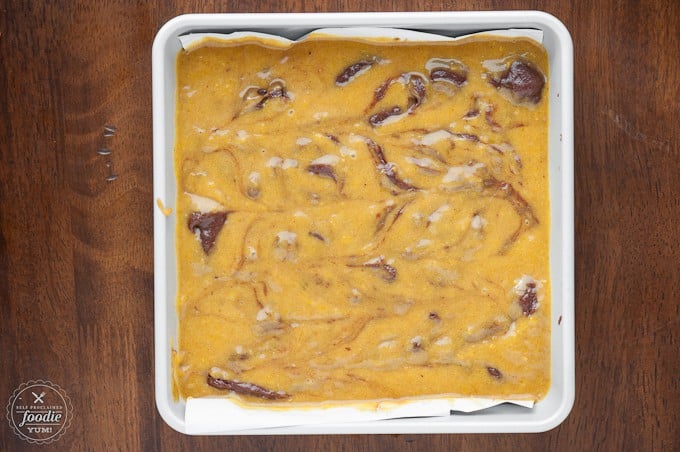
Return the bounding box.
[0,0,680,451]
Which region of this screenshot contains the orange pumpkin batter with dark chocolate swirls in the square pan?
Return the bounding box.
[174,33,550,404]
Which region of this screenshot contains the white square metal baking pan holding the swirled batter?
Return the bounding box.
[152,11,575,434]
